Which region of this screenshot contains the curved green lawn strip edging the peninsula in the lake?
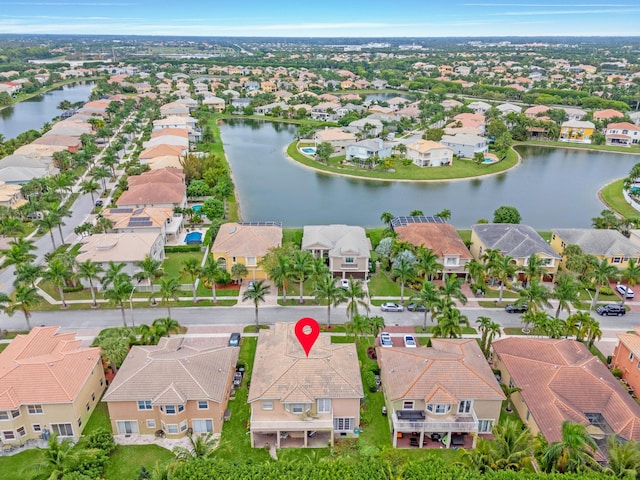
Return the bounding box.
[287,141,518,180]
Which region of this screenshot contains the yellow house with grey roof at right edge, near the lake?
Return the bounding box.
[551,228,640,270]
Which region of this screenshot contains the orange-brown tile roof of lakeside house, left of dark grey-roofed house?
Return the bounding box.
[394,223,473,259]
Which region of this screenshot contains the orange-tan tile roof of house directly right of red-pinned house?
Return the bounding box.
[377,338,505,403]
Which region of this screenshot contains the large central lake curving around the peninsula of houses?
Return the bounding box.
[220,120,640,229]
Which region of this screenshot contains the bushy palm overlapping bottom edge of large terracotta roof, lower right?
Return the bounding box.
[541,420,599,473]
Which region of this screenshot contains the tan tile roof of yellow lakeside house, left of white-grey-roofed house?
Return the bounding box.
[211,222,282,257]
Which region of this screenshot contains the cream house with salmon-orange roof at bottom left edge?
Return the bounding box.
[0,327,106,445]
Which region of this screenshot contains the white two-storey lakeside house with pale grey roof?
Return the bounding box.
[301,225,372,279]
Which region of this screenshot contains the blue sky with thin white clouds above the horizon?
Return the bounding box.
[0,0,640,37]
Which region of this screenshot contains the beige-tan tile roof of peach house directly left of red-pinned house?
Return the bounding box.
[103,337,238,404]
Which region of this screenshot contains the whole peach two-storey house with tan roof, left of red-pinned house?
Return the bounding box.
[102,337,239,438]
